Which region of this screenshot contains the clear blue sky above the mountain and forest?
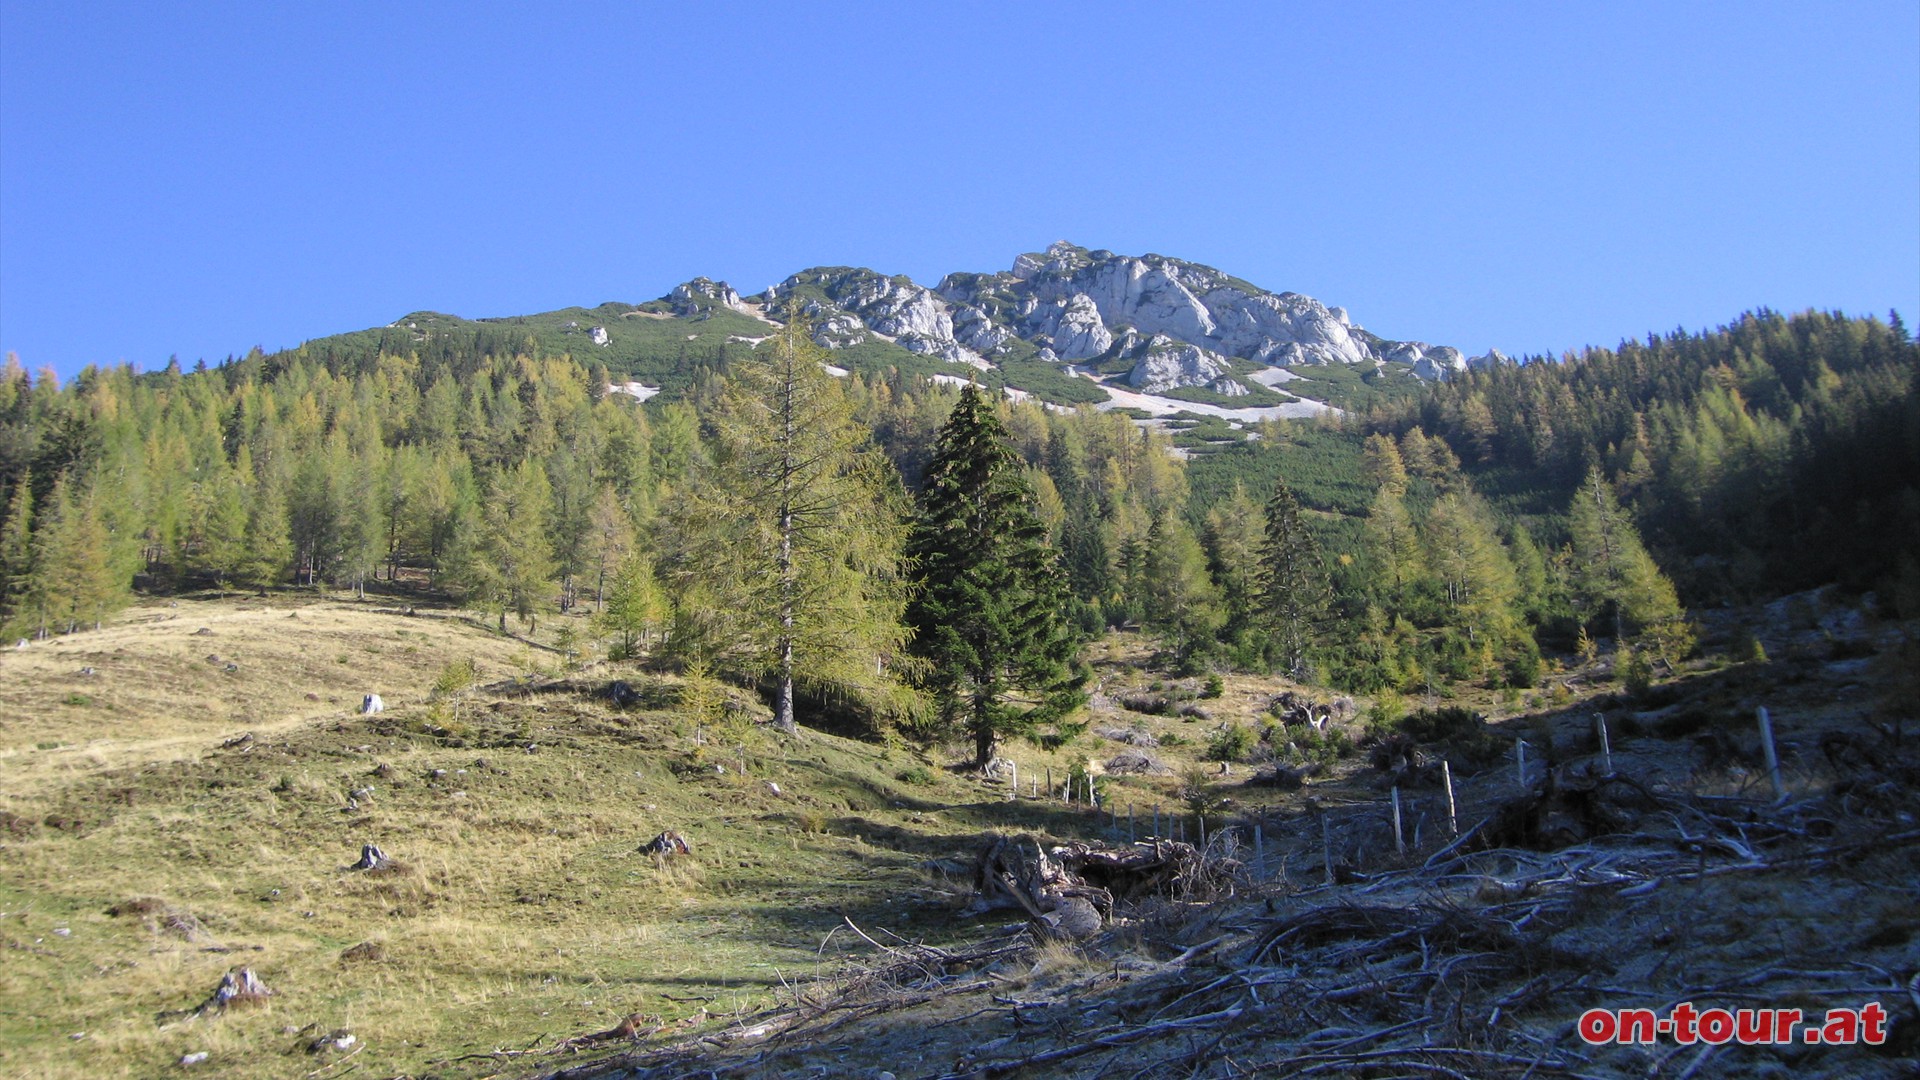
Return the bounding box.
[0,0,1920,375]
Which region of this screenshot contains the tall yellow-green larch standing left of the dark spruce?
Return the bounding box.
[679,309,906,734]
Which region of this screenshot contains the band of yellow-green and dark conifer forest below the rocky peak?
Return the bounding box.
[0,311,1920,726]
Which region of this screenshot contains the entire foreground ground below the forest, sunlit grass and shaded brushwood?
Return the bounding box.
[0,598,1920,1080]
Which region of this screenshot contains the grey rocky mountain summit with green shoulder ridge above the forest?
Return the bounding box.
[280,242,1500,418]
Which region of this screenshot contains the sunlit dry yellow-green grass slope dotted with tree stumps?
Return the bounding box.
[0,600,1031,1078]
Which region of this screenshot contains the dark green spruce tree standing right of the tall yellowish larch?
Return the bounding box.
[906,384,1087,765]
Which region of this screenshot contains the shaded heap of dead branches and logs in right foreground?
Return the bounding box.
[529,730,1920,1080]
